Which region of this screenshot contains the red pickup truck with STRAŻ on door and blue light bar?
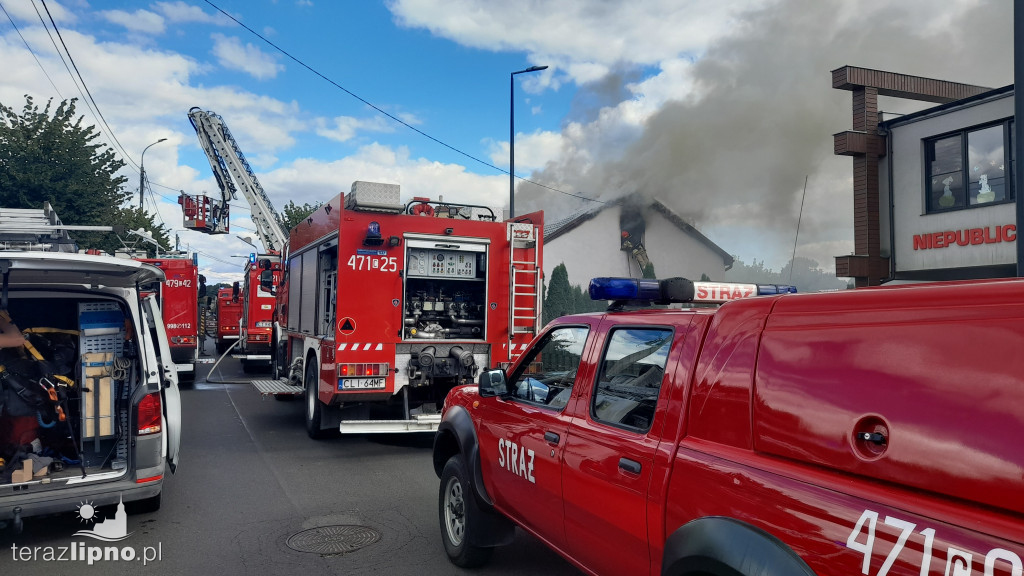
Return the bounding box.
[433,279,1024,576]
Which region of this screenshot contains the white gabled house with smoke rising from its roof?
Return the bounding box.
[544,199,733,290]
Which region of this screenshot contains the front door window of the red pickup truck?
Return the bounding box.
[510,326,590,410]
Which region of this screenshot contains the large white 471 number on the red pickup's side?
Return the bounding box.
[846,510,1024,576]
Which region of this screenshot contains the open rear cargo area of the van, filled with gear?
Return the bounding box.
[0,293,138,483]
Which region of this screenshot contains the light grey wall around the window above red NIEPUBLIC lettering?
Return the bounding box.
[880,93,1017,274]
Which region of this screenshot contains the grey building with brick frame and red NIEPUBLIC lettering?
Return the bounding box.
[833,67,1017,287]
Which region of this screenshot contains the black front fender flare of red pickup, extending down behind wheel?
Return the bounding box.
[433,406,515,547]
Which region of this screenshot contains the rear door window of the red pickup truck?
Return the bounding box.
[591,328,672,431]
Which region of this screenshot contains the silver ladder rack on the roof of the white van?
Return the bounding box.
[0,202,114,252]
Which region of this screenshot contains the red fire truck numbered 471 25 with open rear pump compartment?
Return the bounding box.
[254,181,543,438]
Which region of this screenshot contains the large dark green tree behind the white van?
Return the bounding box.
[0,95,167,251]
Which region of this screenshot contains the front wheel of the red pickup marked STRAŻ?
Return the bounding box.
[437,454,495,568]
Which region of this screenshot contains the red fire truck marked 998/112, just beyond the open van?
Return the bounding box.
[136,253,199,378]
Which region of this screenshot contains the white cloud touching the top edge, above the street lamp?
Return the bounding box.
[388,0,772,83]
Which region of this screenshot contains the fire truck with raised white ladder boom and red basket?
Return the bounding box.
[178,107,288,372]
